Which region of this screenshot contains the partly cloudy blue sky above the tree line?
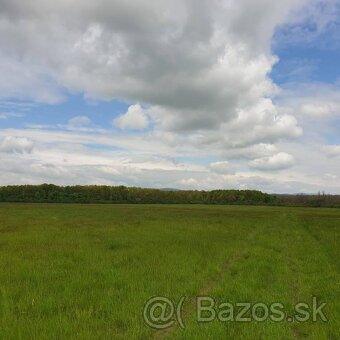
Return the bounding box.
[0,0,340,194]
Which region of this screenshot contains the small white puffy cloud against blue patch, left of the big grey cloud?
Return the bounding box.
[113,104,149,130]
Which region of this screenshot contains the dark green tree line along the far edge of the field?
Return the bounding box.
[0,184,340,208]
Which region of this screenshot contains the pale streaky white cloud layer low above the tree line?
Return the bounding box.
[0,129,340,193]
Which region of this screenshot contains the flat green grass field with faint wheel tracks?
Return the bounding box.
[0,204,340,340]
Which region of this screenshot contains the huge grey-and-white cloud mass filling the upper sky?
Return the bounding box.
[0,0,301,142]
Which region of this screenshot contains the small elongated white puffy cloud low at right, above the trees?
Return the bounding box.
[248,152,295,171]
